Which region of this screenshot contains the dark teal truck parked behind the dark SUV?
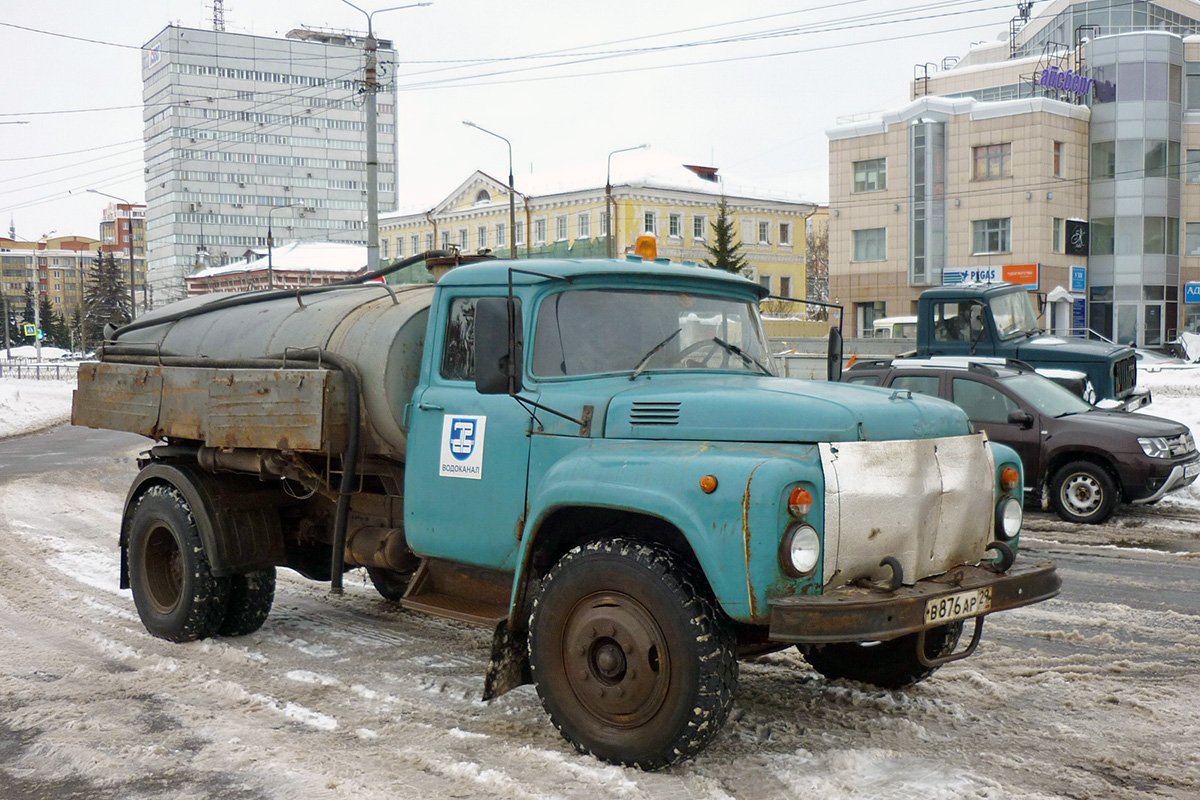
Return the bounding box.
[916,283,1150,409]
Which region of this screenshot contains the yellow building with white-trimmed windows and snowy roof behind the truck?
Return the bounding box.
[379,154,820,297]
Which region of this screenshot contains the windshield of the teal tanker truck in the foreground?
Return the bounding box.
[533,289,774,378]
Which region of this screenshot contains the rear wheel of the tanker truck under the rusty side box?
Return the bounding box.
[128,483,229,642]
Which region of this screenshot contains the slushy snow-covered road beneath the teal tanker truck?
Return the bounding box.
[0,371,1200,800]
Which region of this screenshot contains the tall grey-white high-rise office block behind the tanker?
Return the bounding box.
[142,25,396,306]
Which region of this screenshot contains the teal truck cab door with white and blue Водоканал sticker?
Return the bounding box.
[404,296,535,570]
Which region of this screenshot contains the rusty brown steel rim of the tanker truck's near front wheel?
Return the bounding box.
[562,591,671,728]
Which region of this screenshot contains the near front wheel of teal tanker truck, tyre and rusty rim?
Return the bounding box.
[529,540,738,770]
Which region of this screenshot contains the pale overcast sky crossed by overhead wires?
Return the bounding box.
[0,0,1032,240]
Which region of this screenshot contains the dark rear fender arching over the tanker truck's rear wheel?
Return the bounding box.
[120,462,286,589]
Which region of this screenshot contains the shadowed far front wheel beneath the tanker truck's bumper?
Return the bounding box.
[799,622,962,688]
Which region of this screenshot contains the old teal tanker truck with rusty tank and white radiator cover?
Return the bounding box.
[73,259,1060,769]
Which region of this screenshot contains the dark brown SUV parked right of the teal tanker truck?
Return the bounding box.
[841,357,1200,523]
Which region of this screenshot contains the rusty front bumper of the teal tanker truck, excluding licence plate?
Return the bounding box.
[768,561,1062,644]
